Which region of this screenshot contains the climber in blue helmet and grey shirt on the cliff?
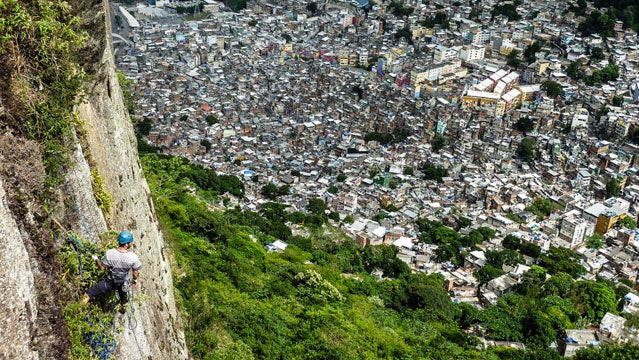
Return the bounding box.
[82,231,142,312]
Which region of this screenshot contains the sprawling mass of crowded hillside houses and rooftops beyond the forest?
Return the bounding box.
[116,0,639,356]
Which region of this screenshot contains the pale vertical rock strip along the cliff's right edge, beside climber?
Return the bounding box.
[73,1,188,360]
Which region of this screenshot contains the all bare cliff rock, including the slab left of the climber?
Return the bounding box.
[0,0,189,360]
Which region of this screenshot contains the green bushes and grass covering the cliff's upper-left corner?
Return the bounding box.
[0,0,87,184]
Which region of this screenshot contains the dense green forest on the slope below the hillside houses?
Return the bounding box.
[141,142,639,359]
